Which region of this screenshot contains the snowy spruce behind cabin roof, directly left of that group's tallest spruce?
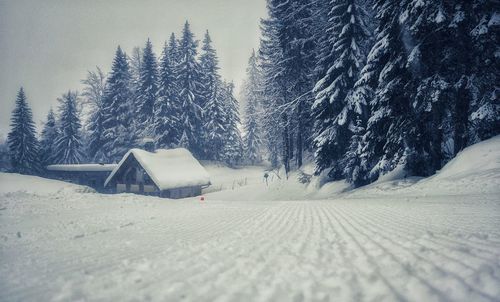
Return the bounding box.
[154,37,182,148]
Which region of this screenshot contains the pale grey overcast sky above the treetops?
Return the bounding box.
[0,0,266,136]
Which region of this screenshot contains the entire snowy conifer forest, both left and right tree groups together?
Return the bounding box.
[8,0,500,186]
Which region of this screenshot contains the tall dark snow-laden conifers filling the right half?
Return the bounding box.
[240,0,500,185]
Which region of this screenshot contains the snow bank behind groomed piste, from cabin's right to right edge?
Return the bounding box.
[205,132,500,201]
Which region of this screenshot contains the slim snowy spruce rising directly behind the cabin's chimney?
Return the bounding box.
[135,39,158,136]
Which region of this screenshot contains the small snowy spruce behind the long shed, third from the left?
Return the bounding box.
[54,91,85,164]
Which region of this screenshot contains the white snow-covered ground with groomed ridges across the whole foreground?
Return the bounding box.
[0,137,500,301]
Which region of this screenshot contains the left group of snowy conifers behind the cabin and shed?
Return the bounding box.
[8,22,243,174]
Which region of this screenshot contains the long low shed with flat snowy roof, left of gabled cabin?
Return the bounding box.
[46,164,118,191]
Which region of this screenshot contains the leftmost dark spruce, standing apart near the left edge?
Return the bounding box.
[7,87,41,174]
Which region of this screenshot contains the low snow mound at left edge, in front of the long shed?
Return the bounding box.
[0,173,95,195]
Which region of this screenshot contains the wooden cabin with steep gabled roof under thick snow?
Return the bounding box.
[104,148,210,198]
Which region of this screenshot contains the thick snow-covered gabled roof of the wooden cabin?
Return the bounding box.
[104,148,210,190]
